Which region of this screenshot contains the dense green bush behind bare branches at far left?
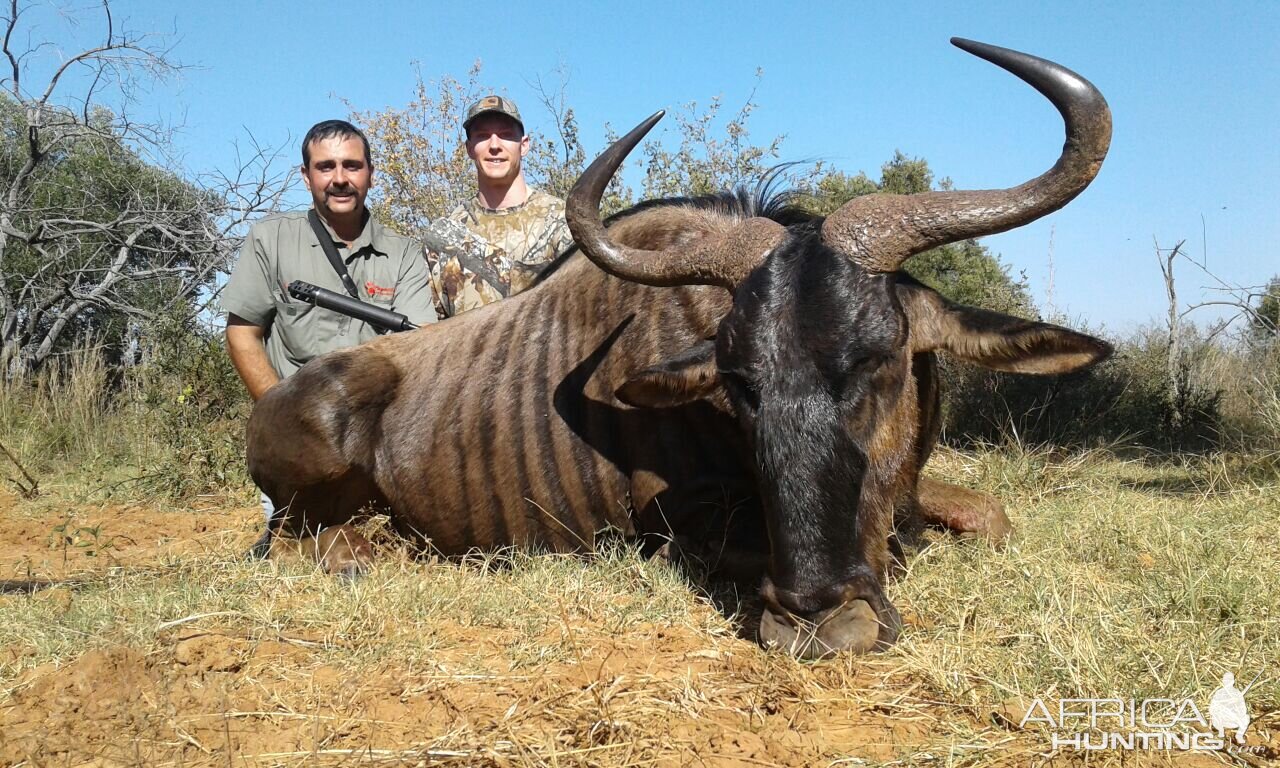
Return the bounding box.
[0,93,224,365]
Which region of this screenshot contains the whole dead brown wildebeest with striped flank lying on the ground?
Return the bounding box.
[248,40,1111,658]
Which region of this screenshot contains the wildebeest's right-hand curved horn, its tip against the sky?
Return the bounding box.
[822,37,1111,271]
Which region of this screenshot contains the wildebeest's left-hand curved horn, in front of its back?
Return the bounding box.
[564,110,786,291]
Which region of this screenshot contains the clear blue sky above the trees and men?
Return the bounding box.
[20,0,1280,332]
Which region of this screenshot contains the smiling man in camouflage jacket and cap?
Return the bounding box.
[424,96,573,317]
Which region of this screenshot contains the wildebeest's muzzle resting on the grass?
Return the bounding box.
[760,600,901,659]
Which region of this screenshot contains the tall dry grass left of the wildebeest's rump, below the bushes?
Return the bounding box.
[0,339,250,502]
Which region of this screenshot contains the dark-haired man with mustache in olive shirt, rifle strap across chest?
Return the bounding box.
[221,120,435,540]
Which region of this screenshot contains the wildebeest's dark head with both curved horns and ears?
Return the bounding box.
[567,40,1111,657]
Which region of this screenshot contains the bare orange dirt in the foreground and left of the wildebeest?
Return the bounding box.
[0,497,1249,767]
